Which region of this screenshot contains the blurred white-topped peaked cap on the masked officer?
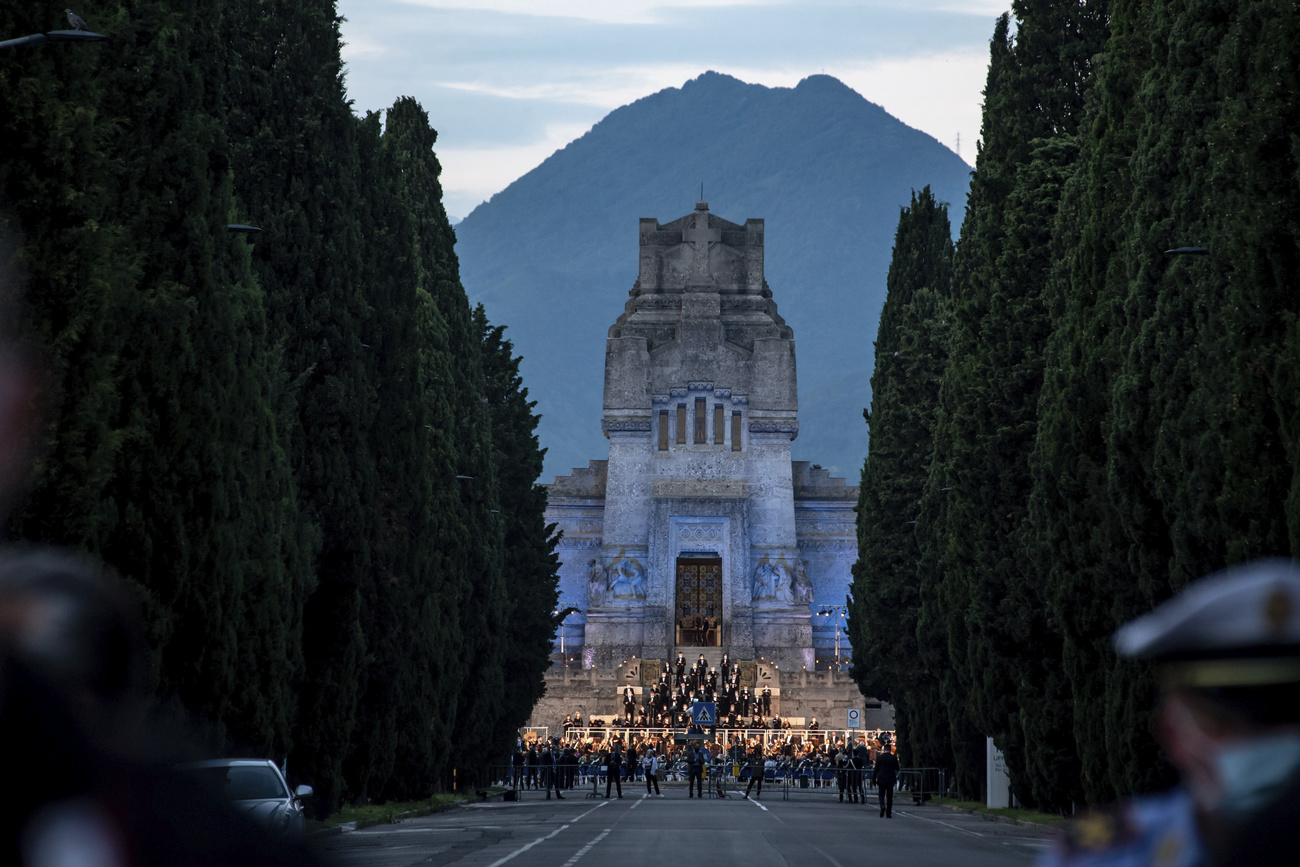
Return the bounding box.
[1114,559,1300,688]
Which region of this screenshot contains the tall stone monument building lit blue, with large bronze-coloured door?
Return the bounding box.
[540,201,889,721]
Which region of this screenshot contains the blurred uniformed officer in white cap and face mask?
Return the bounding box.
[1043,559,1300,867]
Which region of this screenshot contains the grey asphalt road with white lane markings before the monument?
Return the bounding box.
[317,784,1047,867]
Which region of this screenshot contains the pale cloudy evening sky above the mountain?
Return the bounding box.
[338,0,1010,218]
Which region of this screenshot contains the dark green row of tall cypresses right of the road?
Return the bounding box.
[850,0,1300,811]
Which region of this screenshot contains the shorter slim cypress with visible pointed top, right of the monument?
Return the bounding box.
[849,187,953,767]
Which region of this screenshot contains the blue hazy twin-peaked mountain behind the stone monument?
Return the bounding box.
[455,71,970,481]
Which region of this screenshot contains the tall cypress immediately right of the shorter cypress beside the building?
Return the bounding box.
[931,0,1106,809]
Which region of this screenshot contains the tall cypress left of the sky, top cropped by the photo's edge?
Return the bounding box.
[215,0,378,814]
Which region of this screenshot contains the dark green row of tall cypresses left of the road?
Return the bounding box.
[0,0,558,811]
